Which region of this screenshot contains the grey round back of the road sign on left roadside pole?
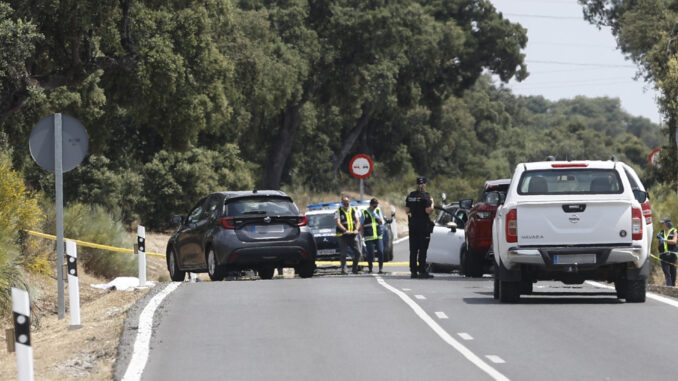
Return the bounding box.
[28,114,89,172]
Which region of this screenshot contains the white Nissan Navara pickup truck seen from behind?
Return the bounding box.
[492,161,652,303]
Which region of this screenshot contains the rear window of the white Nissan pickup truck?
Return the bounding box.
[518,168,624,195]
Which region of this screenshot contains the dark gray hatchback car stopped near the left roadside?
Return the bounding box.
[167,190,316,281]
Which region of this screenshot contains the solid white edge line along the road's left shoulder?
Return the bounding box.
[122,282,182,381]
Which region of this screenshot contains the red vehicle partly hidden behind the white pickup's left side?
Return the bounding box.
[461,179,511,278]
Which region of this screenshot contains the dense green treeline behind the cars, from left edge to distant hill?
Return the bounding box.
[0,0,661,228]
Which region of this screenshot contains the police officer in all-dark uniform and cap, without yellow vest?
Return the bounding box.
[405,176,433,279]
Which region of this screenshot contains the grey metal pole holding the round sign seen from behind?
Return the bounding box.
[54,113,66,320]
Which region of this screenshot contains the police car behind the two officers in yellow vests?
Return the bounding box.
[305,200,397,262]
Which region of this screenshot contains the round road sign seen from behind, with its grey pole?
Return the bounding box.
[28,113,88,319]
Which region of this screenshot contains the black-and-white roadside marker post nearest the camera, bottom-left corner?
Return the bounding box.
[12,287,34,381]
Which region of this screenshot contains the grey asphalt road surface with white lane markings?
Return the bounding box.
[121,241,678,380]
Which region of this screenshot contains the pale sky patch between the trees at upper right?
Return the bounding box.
[491,0,661,123]
